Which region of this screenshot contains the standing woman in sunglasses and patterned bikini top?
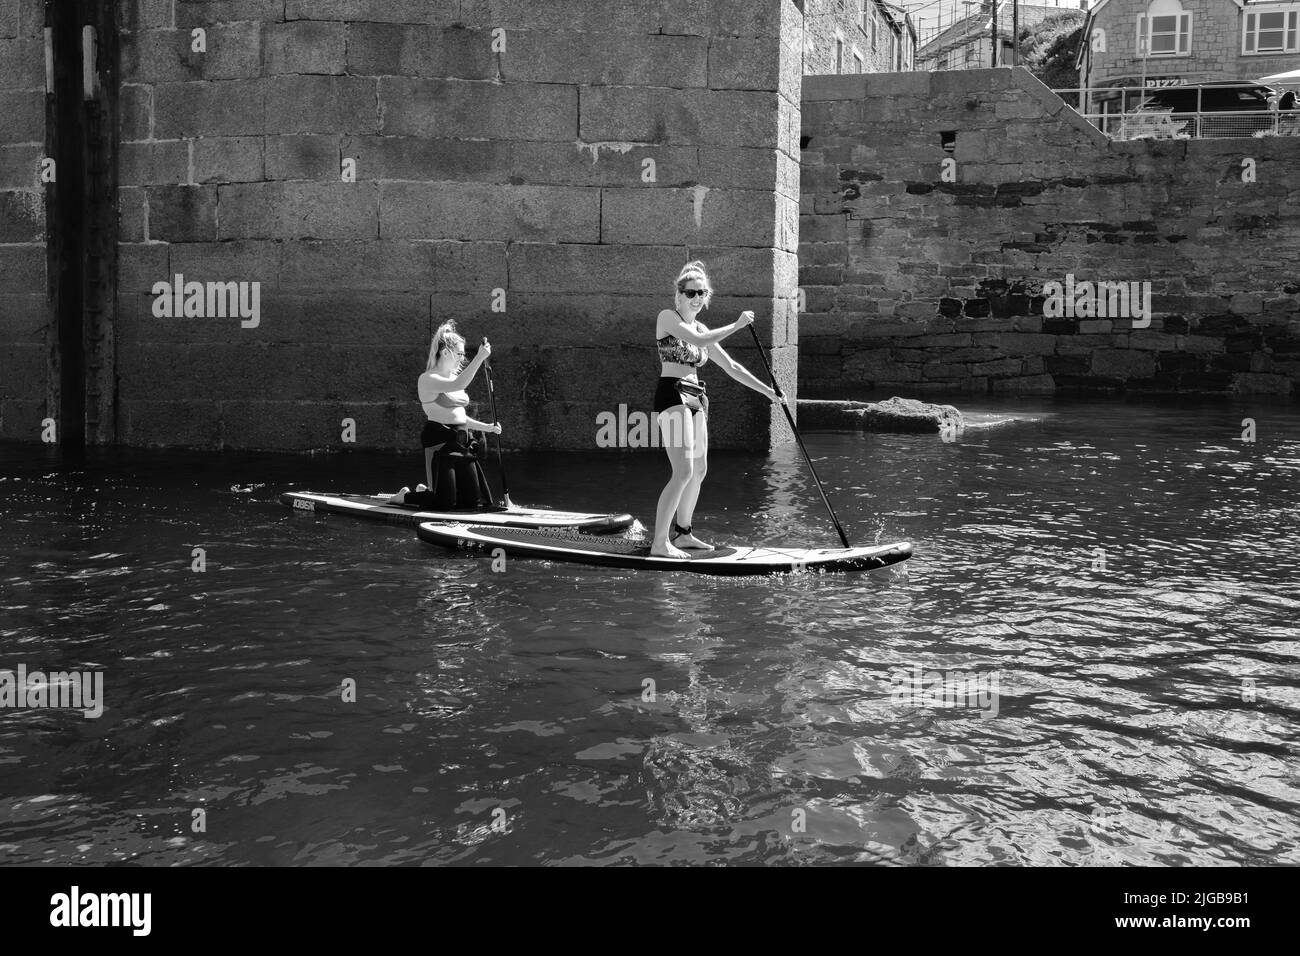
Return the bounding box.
[650,260,779,558]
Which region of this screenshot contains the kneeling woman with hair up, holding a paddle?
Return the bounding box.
[393,321,501,511]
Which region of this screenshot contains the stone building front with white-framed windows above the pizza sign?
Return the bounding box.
[1079,0,1300,96]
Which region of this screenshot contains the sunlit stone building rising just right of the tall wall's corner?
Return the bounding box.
[803,0,917,75]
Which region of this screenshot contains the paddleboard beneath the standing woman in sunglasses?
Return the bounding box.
[416,522,911,575]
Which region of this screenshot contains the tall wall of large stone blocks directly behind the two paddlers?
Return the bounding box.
[117,0,802,449]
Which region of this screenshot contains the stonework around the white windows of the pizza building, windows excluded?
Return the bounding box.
[1092,0,1300,86]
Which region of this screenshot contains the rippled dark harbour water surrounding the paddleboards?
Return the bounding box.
[0,402,1300,865]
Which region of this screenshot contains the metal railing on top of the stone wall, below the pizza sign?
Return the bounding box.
[1054,85,1300,139]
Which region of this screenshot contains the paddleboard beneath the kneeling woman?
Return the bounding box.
[280,492,632,535]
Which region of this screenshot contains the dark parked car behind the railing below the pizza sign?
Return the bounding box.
[1122,81,1281,139]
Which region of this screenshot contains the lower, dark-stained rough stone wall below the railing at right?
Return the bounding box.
[800,69,1300,398]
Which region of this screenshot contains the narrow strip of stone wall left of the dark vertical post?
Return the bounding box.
[0,0,45,441]
